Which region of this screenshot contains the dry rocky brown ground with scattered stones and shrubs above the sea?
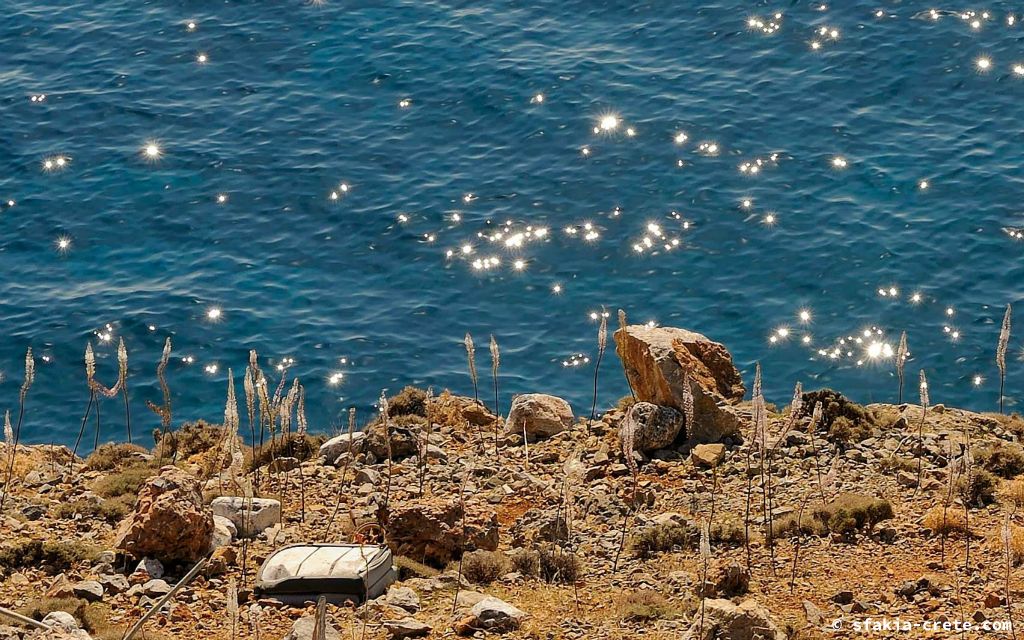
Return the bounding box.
[0,327,1024,640]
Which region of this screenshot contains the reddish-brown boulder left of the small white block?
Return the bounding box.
[114,466,214,562]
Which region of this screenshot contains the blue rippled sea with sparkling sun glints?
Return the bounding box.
[0,0,1024,443]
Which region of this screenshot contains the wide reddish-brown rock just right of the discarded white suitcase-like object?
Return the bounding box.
[388,498,498,566]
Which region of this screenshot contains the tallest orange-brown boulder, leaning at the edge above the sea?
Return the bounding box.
[614,325,745,443]
